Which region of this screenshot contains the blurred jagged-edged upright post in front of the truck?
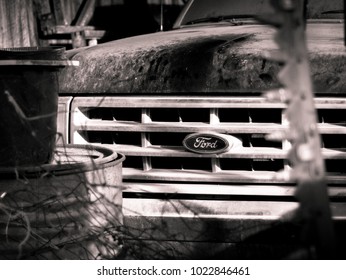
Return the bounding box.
[262,0,336,259]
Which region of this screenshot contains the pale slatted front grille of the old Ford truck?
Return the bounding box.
[70,95,346,198]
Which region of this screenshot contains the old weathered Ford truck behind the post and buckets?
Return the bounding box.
[58,0,346,259]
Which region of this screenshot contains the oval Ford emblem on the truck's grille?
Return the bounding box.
[183,132,242,154]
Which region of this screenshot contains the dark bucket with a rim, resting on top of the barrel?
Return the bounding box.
[0,47,75,166]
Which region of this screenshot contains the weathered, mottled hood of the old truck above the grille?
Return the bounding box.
[59,23,346,95]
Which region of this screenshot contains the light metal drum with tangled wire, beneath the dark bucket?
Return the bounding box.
[0,145,125,260]
